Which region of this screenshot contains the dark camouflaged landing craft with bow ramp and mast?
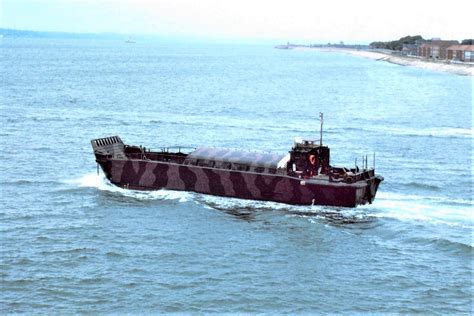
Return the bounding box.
[91,115,383,207]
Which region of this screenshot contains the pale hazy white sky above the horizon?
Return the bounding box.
[0,0,474,43]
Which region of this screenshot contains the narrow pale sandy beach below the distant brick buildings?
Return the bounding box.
[296,47,474,76]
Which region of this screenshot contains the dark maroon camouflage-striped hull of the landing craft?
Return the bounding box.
[95,136,383,207]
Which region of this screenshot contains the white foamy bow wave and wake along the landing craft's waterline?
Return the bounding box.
[67,173,474,228]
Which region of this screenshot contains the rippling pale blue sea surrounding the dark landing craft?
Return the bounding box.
[0,38,474,314]
